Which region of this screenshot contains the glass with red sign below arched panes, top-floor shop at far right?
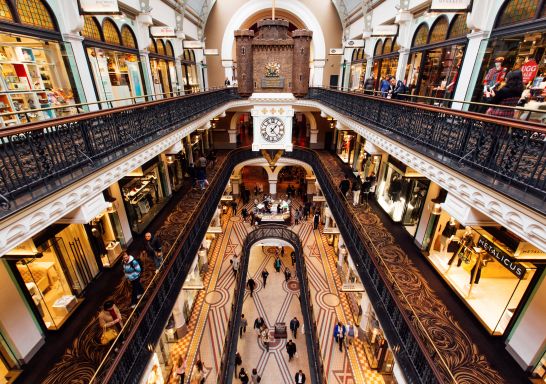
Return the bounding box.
[467,31,546,122]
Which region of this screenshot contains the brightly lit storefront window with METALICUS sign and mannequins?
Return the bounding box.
[428,212,536,335]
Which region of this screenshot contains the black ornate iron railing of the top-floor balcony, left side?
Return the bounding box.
[0,88,238,218]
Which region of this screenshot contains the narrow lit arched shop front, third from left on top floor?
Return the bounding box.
[148,39,179,97]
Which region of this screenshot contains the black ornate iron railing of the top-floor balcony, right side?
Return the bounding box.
[308,88,546,213]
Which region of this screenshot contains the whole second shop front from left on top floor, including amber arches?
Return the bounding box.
[81,16,146,107]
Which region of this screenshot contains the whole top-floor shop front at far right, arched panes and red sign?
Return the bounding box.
[467,0,546,118]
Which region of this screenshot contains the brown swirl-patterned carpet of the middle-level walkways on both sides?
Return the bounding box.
[20,149,526,384]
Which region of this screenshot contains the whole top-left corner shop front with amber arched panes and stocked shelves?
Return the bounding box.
[0,2,85,128]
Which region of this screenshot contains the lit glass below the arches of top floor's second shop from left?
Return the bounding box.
[87,47,144,107]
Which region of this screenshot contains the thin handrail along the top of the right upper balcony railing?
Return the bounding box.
[336,87,546,125]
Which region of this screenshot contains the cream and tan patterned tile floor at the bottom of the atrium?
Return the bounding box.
[171,201,388,384]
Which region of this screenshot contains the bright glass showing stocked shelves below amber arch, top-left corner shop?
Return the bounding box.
[0,33,85,127]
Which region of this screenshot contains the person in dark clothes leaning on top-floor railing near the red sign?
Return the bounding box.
[484,69,524,118]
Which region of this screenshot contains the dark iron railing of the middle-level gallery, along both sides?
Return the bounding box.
[91,147,458,384]
